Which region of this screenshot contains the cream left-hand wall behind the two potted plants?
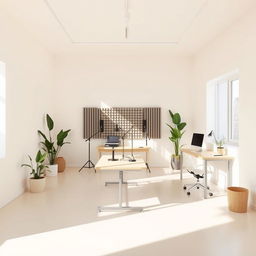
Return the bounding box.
[0,13,52,207]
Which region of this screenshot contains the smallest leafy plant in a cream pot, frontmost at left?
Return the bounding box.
[21,150,47,193]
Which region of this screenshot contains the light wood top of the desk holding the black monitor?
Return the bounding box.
[181,148,234,161]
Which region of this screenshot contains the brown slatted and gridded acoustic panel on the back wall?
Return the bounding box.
[84,108,161,139]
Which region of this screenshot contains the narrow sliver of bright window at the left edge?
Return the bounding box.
[0,62,5,158]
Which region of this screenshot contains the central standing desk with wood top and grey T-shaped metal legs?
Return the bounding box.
[95,155,147,212]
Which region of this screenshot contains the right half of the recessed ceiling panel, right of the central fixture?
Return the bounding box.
[128,0,206,42]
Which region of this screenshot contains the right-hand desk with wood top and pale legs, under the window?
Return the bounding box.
[180,148,234,198]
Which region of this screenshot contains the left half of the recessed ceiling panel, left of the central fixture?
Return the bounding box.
[46,0,125,43]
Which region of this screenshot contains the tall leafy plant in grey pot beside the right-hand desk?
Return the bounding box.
[167,110,187,170]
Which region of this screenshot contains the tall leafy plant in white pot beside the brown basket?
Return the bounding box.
[38,114,71,176]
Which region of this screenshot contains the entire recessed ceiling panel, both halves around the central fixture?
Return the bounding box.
[45,0,206,43]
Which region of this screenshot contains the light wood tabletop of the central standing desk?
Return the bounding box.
[95,155,147,171]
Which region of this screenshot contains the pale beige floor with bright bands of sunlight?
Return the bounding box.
[0,169,256,256]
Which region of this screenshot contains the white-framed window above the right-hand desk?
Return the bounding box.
[207,72,239,144]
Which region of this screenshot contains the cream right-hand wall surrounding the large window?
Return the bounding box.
[194,10,256,205]
